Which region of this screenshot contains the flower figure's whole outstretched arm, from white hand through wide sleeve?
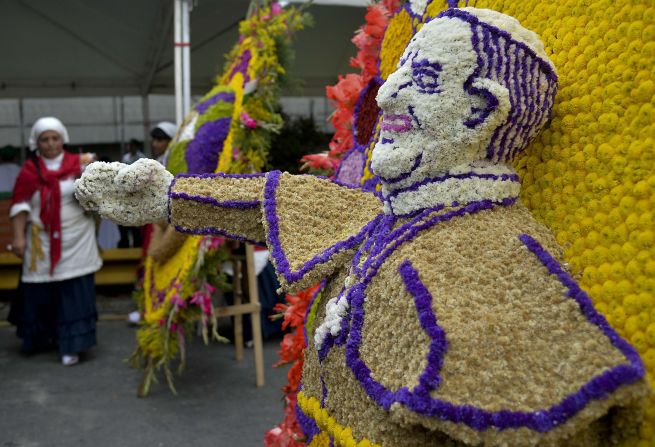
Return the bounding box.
[75,159,382,290]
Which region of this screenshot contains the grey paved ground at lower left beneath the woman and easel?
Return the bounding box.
[0,296,287,447]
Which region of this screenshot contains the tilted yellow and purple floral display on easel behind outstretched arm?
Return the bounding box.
[131,1,309,395]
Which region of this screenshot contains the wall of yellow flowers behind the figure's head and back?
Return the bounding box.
[372,0,655,447]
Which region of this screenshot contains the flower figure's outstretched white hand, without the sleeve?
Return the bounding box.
[75,158,173,226]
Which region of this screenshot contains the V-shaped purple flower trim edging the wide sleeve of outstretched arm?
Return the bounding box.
[264,171,380,283]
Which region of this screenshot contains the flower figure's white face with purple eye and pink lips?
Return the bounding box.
[371,18,484,187]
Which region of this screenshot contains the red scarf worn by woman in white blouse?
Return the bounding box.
[11,151,81,275]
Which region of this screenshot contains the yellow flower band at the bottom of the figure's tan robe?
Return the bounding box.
[298,391,379,447]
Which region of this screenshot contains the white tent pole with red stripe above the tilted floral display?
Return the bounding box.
[174,0,191,125]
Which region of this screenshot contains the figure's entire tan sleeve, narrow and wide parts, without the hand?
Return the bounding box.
[169,171,382,291]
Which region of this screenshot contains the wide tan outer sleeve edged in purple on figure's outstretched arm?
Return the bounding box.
[263,171,382,290]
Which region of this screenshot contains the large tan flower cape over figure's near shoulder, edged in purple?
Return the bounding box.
[346,205,646,445]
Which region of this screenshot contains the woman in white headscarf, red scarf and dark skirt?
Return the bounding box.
[9,117,102,366]
